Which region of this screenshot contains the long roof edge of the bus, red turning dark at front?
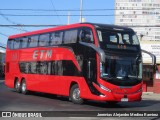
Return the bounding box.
[9,23,133,39]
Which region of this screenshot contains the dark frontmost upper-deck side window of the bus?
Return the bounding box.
[79,28,94,43]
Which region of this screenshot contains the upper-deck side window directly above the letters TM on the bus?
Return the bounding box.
[39,34,50,46]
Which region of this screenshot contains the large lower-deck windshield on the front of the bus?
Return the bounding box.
[101,55,142,86]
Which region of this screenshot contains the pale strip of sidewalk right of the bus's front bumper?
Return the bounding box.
[142,92,160,101]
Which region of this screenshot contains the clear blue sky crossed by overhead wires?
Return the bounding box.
[0,0,114,44]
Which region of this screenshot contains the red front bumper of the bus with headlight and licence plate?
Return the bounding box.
[82,80,142,102]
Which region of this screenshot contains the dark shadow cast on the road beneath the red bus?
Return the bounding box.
[14,89,159,111]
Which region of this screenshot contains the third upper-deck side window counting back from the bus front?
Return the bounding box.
[50,32,63,45]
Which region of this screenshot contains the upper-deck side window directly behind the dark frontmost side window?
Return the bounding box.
[64,30,78,43]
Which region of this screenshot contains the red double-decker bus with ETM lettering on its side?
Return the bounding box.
[5,23,142,104]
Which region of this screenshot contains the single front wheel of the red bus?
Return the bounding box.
[70,84,83,104]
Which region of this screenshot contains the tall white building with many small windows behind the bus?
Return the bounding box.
[115,0,160,41]
